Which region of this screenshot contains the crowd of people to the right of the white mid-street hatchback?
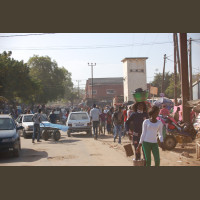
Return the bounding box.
[88,102,198,166]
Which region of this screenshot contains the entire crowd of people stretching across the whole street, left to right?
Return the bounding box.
[0,99,198,166]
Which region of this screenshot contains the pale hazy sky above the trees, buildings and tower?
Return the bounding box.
[0,33,200,89]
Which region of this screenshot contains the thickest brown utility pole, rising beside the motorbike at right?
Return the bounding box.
[179,33,190,123]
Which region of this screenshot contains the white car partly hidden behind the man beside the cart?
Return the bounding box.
[16,114,48,138]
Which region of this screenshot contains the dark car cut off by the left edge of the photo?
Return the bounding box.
[0,114,23,157]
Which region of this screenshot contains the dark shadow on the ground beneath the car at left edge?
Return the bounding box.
[0,148,48,164]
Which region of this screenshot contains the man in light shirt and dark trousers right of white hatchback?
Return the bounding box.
[90,104,101,140]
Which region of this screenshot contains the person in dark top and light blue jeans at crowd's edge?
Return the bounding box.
[113,107,124,144]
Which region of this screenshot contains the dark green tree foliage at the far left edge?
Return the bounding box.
[0,51,39,102]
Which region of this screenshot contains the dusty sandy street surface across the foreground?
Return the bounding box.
[0,132,200,166]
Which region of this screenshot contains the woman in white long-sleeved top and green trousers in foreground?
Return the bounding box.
[136,106,164,166]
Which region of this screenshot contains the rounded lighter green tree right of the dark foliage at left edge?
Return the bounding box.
[28,55,73,103]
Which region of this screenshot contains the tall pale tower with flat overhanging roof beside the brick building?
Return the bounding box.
[122,57,148,101]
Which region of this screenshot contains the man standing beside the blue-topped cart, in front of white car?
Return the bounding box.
[32,109,42,143]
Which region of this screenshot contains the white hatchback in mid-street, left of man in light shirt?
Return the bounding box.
[66,112,92,137]
